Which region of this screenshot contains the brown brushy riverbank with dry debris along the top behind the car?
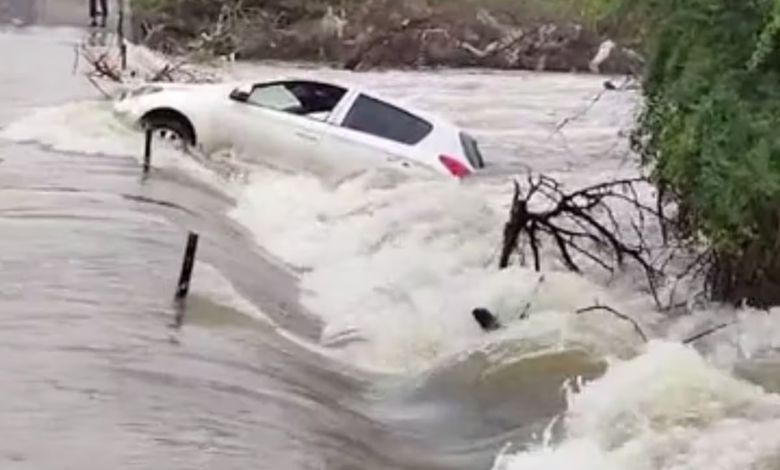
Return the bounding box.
[128,0,638,74]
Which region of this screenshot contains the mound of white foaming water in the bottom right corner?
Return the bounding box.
[494,342,780,470]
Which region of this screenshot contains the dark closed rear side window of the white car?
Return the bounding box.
[343,95,433,145]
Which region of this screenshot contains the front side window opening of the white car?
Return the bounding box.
[247,81,346,119]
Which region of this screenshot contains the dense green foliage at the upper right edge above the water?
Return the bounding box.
[613,0,780,255]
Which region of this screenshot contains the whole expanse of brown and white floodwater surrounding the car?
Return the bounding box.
[0,19,780,470]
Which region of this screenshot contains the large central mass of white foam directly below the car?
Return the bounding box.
[232,168,660,371]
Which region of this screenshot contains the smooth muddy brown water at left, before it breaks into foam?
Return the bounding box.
[0,20,592,469]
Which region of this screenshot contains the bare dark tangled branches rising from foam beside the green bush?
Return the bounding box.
[499,175,664,306]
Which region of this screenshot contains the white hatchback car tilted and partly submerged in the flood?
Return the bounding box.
[114,79,484,178]
